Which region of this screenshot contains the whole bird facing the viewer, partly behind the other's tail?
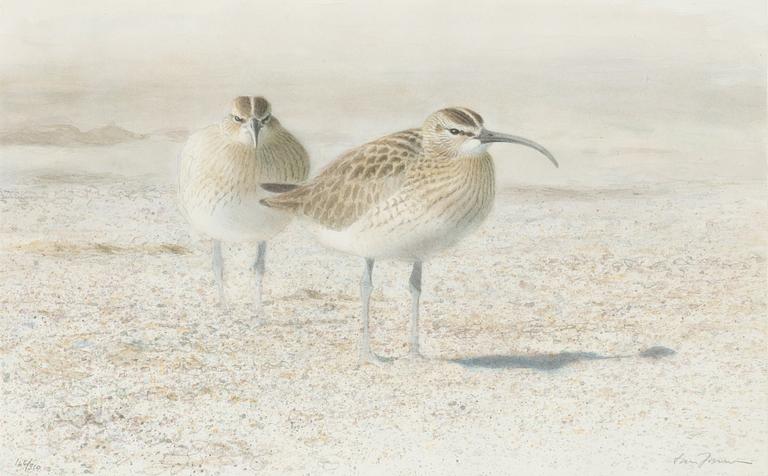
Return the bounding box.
[179,96,309,309]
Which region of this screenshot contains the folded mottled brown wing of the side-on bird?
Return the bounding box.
[262,129,422,230]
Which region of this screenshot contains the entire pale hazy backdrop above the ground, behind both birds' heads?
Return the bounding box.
[0,0,768,185]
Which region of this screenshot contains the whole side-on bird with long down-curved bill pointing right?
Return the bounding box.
[262,108,557,361]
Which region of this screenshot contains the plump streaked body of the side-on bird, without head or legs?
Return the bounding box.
[264,109,495,260]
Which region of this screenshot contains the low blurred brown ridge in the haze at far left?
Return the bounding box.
[0,124,149,147]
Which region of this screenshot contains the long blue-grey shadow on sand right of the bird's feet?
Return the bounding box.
[449,346,676,371]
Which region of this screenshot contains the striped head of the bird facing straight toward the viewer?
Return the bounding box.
[221,96,277,148]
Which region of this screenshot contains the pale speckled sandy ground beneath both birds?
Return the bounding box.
[0,166,768,475]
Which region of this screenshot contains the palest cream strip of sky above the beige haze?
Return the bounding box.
[0,0,766,82]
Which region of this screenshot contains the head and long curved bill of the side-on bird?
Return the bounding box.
[422,107,558,167]
